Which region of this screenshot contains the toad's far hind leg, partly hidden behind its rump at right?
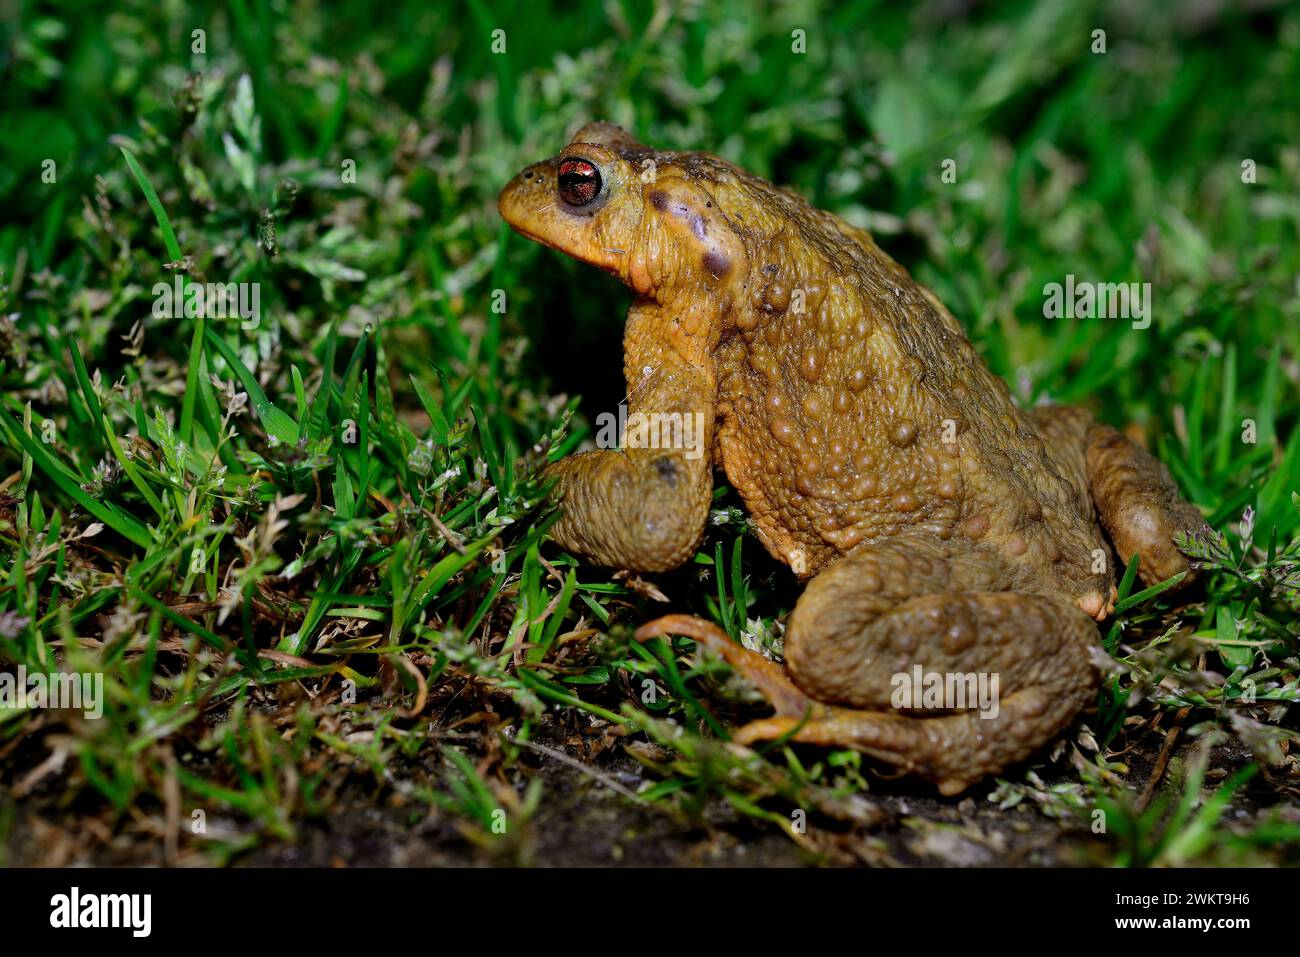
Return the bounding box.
[1087,423,1205,585]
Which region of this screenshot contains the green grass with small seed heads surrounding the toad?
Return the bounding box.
[0,0,1300,865]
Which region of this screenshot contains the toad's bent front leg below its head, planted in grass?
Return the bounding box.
[546,304,716,572]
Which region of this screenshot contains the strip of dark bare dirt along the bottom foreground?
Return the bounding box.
[0,722,1296,867]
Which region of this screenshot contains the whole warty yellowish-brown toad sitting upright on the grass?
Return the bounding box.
[499,124,1203,794]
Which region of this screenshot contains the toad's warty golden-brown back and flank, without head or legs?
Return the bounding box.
[699,157,1096,584]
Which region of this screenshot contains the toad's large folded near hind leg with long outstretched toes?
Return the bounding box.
[642,536,1097,794]
